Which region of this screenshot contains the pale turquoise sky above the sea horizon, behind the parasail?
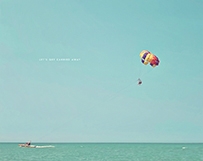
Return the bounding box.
[0,0,203,143]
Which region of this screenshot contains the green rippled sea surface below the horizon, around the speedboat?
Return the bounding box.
[0,143,203,161]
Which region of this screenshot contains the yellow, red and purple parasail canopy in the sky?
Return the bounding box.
[140,50,159,67]
